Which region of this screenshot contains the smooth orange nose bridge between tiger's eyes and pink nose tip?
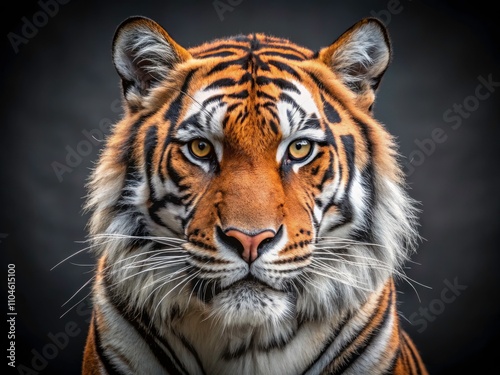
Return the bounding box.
[219,159,284,233]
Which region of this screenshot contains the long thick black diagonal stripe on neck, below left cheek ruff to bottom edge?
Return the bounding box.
[104,275,188,375]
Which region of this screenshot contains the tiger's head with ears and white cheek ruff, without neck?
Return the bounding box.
[87,17,417,334]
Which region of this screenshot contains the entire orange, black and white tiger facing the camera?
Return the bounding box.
[83,17,427,375]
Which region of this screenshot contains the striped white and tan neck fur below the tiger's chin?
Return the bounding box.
[165,280,399,374]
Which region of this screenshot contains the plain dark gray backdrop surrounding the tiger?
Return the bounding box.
[0,0,500,374]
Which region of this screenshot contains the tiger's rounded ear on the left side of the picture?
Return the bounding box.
[113,17,191,108]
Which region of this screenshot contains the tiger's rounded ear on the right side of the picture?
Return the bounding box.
[319,18,391,111]
